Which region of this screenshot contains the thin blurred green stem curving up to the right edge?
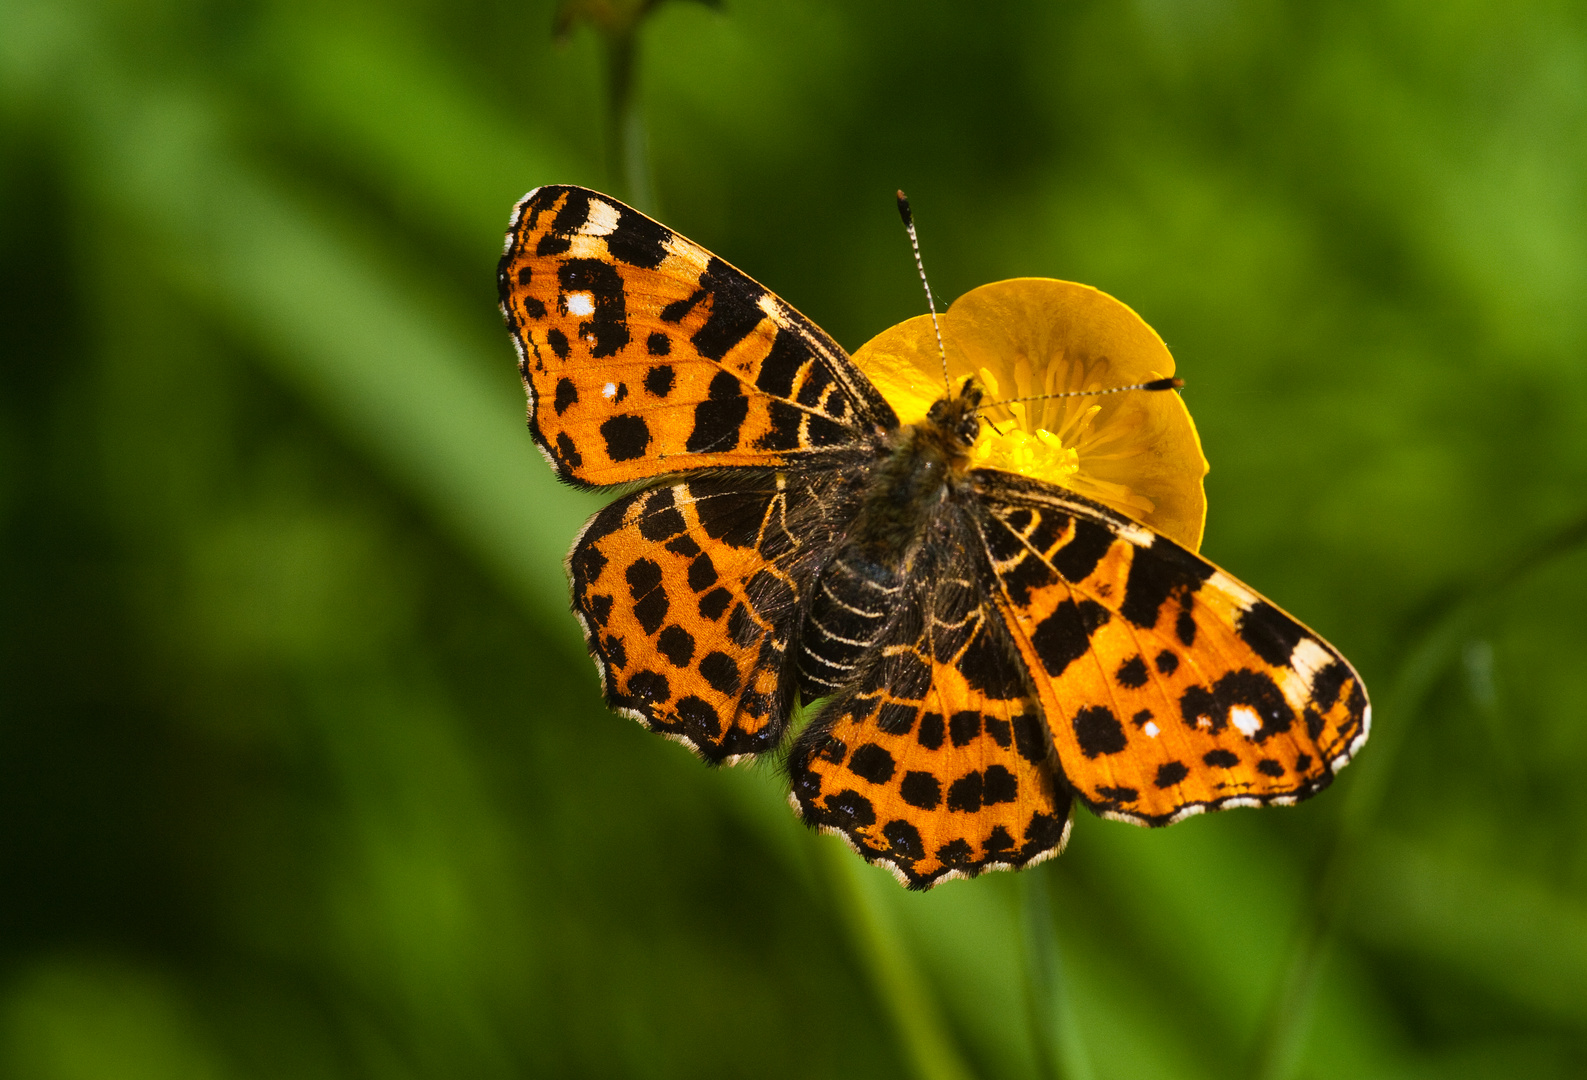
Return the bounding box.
[1252,517,1587,1080]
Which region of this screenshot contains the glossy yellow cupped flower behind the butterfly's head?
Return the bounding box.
[854,278,1208,550]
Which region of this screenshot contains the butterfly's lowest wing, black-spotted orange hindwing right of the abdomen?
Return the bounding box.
[787,529,1071,888]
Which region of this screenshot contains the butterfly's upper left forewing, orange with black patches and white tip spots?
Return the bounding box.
[498,186,898,487]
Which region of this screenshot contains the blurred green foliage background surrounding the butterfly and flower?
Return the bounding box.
[0,0,1587,1080]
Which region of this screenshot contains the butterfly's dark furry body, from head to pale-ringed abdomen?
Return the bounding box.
[800,381,981,699]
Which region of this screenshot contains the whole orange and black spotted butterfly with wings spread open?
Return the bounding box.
[498,186,1371,888]
